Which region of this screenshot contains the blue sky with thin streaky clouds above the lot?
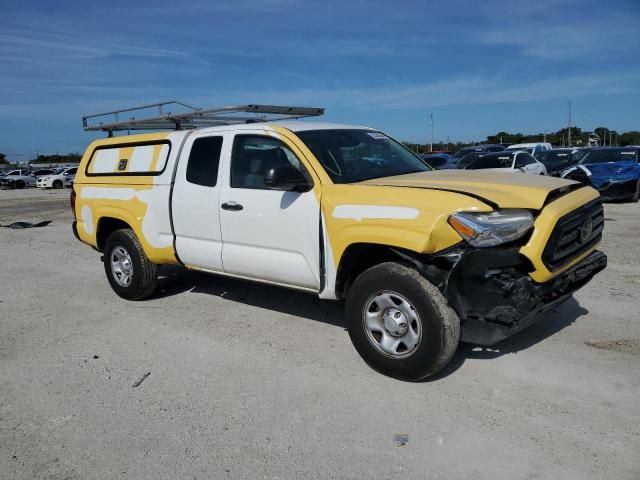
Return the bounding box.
[0,0,640,160]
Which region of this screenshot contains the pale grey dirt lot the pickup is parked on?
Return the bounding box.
[0,189,640,480]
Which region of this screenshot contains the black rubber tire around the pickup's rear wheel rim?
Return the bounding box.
[104,229,158,300]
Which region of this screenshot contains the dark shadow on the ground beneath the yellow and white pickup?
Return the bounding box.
[151,266,589,382]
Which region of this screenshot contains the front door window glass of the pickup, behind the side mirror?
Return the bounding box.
[231,135,304,190]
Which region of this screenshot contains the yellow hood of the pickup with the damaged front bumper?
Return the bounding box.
[361,170,579,210]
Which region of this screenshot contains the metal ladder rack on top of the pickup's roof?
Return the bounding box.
[82,100,324,137]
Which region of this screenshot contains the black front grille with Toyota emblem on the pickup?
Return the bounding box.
[542,198,604,270]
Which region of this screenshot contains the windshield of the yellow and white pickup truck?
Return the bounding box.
[296,129,432,183]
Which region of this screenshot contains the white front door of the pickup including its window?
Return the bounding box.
[220,131,320,291]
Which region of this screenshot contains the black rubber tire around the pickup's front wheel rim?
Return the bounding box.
[345,262,460,381]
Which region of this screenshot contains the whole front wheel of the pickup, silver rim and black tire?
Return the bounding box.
[346,262,460,381]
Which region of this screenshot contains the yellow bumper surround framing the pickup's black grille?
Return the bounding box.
[520,183,600,283]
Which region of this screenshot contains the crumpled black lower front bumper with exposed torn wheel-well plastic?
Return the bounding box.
[442,248,607,346]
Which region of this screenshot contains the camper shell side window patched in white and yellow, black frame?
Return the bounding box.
[86,140,171,177]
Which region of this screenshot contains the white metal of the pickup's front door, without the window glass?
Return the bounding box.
[220,130,320,291]
